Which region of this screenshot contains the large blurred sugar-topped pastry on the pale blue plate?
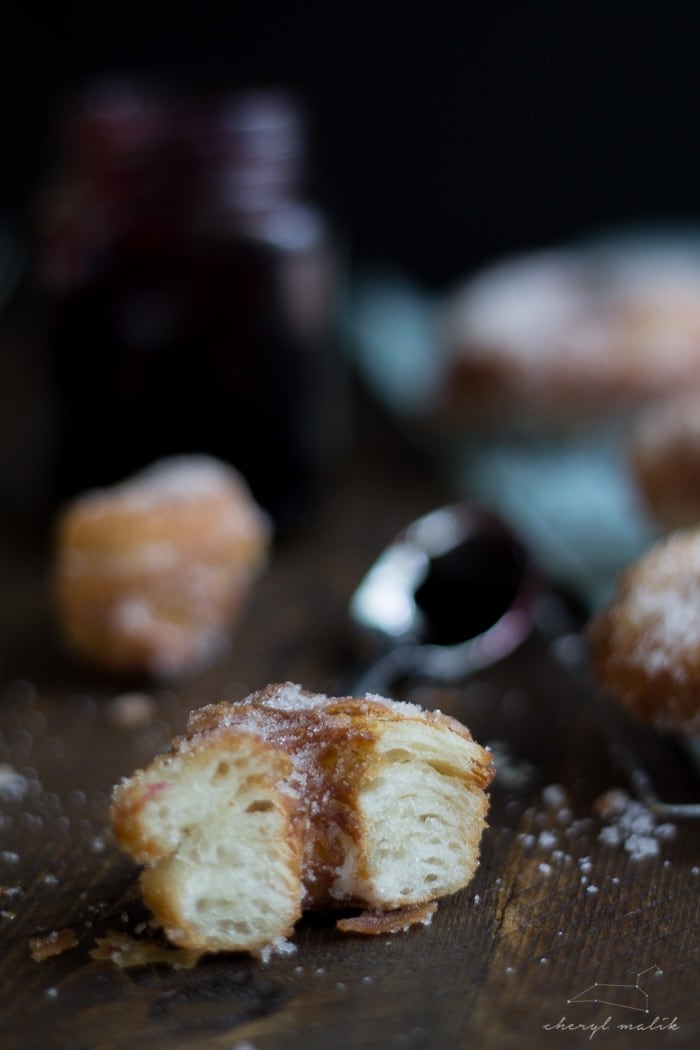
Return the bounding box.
[440,247,700,428]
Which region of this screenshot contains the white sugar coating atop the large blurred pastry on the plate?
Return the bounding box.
[452,244,700,371]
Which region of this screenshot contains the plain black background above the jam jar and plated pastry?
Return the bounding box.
[0,0,700,288]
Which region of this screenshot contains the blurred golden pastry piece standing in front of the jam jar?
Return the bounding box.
[55,455,270,679]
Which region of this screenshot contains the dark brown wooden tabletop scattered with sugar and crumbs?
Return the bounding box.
[0,289,700,1050]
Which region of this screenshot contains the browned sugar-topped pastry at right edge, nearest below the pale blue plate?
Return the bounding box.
[587,529,700,736]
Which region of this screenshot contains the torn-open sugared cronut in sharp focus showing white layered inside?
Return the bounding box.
[112,683,493,950]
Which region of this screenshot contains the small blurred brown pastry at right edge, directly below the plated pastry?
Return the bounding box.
[628,391,700,529]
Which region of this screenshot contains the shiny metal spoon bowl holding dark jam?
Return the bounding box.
[349,503,540,694]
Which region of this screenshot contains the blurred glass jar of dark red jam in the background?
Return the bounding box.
[38,80,343,529]
